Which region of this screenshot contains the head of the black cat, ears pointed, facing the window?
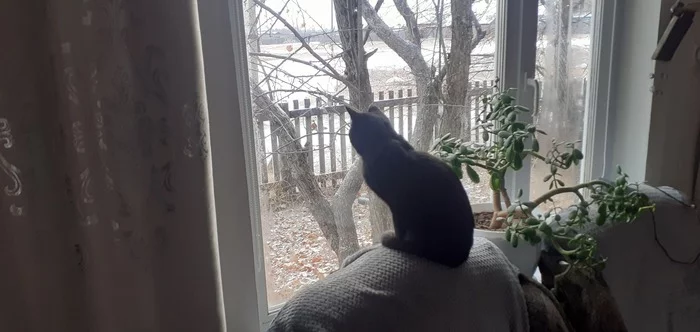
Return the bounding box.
[345,105,398,157]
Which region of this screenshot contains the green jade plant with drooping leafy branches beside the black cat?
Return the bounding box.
[432,90,653,268]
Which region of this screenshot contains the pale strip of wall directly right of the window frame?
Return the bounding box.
[605,0,661,181]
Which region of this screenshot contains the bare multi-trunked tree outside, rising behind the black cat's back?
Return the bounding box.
[362,0,485,240]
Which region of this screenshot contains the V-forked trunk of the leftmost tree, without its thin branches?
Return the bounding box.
[249,0,372,263]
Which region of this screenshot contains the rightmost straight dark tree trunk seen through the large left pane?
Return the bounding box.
[437,0,475,137]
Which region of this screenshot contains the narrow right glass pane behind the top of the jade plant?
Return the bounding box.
[530,0,595,207]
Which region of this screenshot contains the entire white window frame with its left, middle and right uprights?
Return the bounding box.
[197,0,617,331]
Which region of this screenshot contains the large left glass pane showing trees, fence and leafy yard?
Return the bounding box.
[245,0,498,307]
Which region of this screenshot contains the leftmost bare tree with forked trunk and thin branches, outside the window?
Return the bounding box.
[251,0,372,261]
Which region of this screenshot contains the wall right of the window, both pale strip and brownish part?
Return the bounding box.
[605,0,700,196]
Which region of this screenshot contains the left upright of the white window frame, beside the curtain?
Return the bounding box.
[197,0,269,332]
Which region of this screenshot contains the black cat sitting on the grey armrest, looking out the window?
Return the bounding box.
[347,106,474,267]
